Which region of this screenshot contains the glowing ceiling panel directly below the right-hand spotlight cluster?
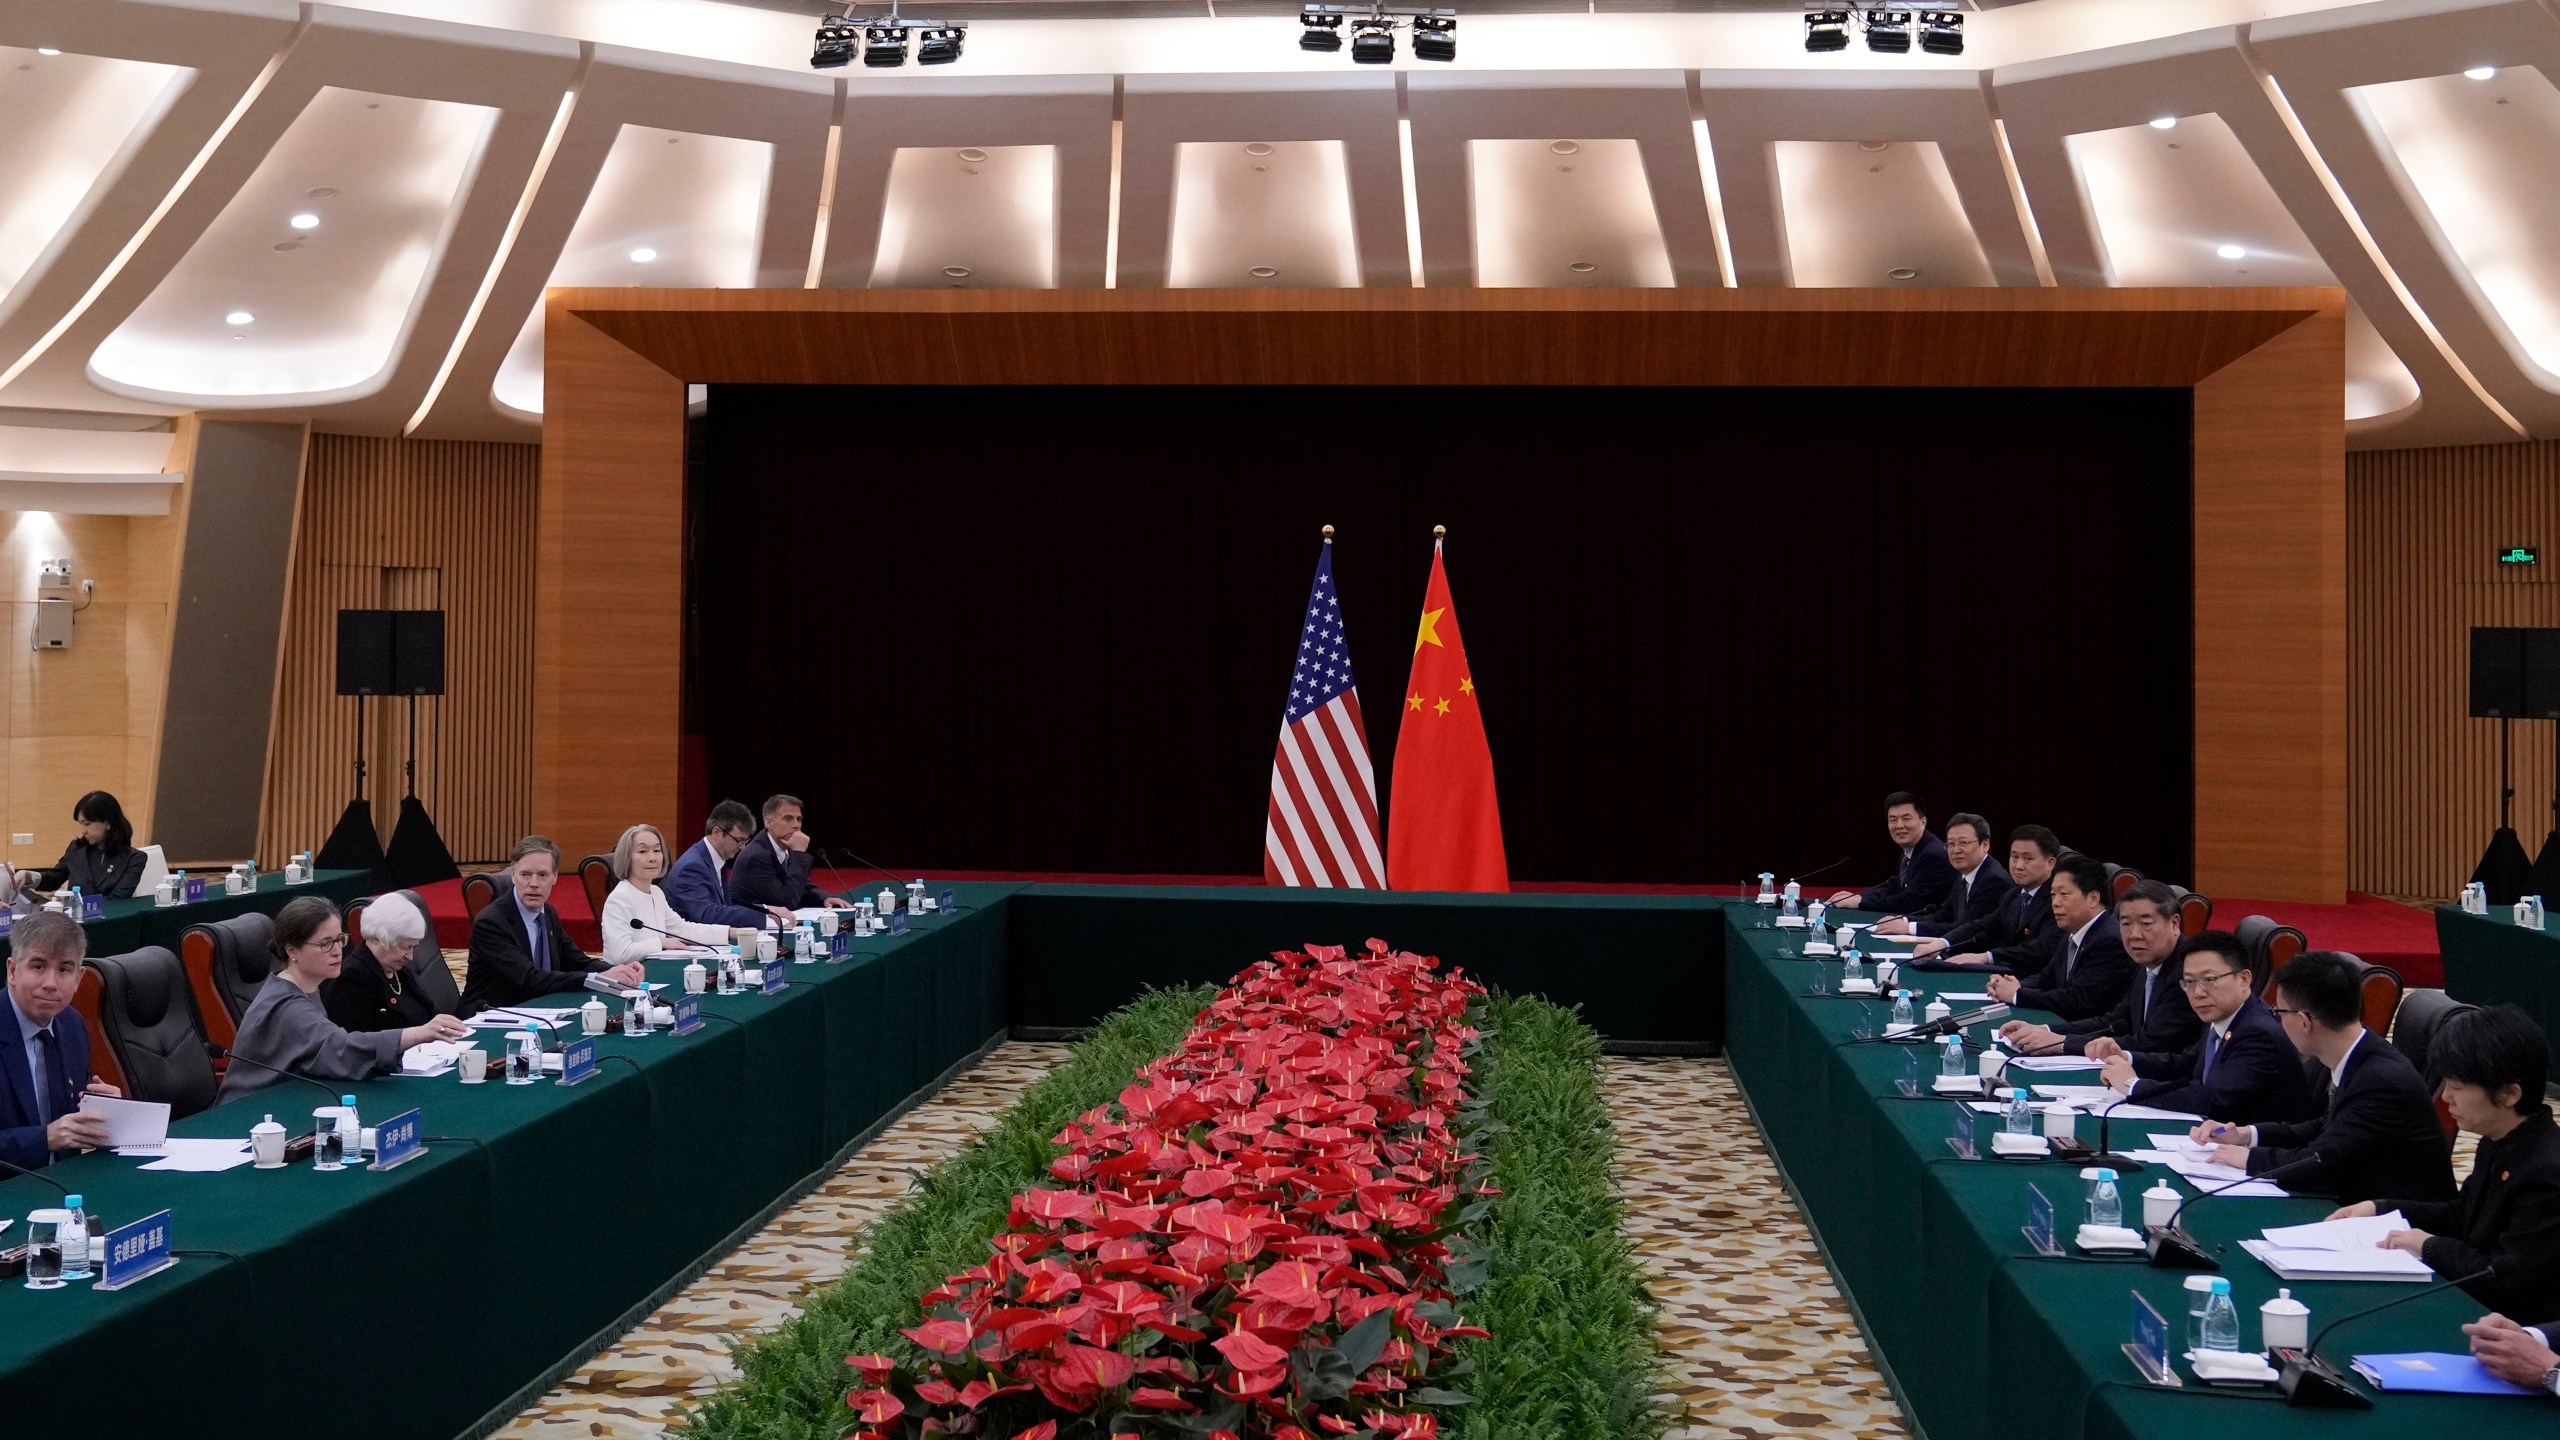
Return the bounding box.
[1777,141,1994,287]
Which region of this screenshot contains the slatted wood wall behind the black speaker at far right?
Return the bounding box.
[2348,441,2560,899]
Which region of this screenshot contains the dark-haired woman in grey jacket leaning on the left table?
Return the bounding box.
[218,894,471,1099]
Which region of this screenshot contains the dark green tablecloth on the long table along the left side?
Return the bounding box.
[0,884,1014,1440]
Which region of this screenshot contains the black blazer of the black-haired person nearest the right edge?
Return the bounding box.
[2385,1101,2560,1314]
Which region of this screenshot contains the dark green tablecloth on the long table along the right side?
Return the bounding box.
[1725,904,2529,1440]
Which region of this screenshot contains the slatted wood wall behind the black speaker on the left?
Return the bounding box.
[259,436,543,866]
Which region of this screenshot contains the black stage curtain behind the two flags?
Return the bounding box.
[686,384,2194,884]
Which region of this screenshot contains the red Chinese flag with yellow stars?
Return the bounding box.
[1388,541,1510,889]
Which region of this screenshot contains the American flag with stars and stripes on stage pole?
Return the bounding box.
[1262,541,1388,889]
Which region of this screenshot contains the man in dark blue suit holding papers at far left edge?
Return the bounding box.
[0,910,123,1171]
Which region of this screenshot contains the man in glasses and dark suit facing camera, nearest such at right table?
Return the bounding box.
[2089,930,2317,1125]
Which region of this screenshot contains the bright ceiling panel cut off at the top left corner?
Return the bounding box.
[0,46,189,310]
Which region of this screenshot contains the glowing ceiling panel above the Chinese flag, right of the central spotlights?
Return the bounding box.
[1467,141,1672,287]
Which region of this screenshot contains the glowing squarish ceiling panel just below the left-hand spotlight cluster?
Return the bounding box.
[870,146,1057,290]
